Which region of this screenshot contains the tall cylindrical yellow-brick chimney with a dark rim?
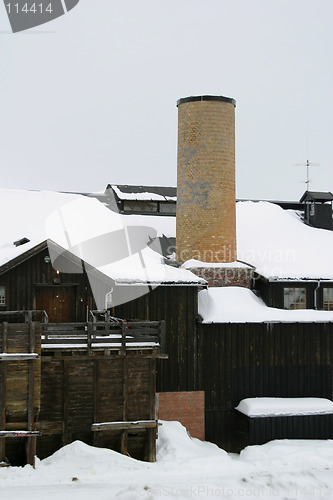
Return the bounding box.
[176,95,236,263]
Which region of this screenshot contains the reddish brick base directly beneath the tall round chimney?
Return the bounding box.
[188,267,253,289]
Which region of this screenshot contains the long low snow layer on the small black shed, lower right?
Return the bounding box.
[236,398,333,417]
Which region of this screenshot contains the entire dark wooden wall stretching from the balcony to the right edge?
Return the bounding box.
[113,286,333,451]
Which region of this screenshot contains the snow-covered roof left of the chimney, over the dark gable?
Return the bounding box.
[0,190,205,285]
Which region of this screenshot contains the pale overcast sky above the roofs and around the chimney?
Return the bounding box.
[0,0,333,199]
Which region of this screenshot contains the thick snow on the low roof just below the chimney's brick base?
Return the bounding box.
[198,286,333,323]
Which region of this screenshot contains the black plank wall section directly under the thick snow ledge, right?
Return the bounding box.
[198,323,333,451]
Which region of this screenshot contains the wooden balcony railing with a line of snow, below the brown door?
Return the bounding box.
[42,321,166,355]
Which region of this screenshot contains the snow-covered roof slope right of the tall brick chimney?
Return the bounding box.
[236,202,333,279]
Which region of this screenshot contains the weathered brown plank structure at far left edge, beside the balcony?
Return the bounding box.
[0,322,41,464]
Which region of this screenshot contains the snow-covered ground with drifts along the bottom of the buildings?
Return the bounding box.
[0,422,333,500]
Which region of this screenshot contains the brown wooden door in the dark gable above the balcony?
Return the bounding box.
[36,285,76,323]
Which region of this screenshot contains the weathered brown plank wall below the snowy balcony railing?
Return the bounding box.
[37,350,156,461]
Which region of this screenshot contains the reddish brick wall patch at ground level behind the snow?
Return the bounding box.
[158,391,205,440]
